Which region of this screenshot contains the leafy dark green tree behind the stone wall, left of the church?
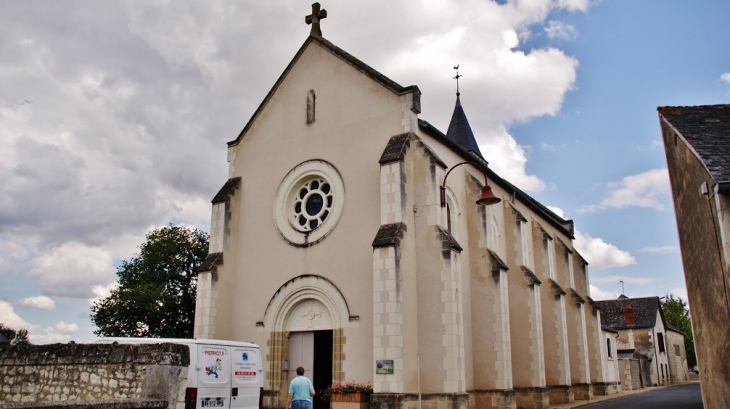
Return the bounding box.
[91,224,208,338]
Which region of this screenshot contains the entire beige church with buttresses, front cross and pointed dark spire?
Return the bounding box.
[195,4,618,408]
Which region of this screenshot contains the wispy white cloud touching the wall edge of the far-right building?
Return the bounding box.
[578,168,671,212]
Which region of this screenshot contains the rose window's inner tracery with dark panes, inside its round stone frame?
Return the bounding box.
[293,178,333,231]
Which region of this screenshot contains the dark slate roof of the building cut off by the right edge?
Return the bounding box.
[657,105,730,189]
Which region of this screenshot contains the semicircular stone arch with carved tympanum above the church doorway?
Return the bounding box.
[263,275,357,332]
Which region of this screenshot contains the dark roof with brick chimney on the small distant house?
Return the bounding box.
[596,297,659,329]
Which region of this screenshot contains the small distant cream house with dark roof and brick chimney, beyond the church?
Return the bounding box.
[596,295,671,386]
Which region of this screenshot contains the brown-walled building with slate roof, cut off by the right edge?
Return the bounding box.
[658,105,730,408]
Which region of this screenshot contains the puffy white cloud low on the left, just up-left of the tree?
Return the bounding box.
[28,242,115,298]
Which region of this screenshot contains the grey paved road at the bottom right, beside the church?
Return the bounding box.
[584,383,702,409]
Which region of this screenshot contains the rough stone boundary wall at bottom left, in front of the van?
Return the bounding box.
[0,343,190,409]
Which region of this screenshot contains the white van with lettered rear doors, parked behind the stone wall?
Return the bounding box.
[94,338,263,409]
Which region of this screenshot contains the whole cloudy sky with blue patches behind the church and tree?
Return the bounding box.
[0,0,730,343]
